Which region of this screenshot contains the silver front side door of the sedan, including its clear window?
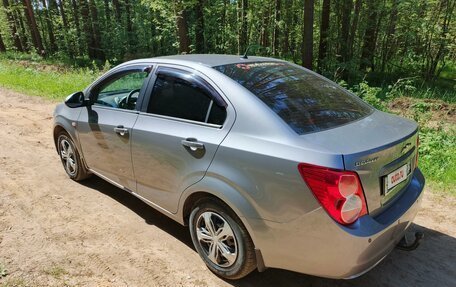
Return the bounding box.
[77,66,147,191]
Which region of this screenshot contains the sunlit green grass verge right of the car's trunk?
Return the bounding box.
[352,83,456,196]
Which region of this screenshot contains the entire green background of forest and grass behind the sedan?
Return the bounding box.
[0,0,456,195]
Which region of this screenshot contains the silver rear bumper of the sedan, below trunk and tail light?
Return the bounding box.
[250,169,425,278]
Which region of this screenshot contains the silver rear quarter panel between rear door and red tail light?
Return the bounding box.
[206,132,343,222]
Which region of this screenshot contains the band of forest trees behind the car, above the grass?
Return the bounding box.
[0,0,456,83]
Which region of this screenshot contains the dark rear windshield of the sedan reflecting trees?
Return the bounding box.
[214,62,373,135]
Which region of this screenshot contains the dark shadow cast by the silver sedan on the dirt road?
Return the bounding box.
[83,176,456,287]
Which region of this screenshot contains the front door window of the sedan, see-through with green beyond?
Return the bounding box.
[93,70,148,110]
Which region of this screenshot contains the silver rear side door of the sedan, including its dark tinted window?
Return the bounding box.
[132,66,234,213]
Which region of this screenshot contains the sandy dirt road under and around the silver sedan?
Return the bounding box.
[0,89,456,287]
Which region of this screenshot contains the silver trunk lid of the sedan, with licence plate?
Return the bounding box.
[301,111,417,216]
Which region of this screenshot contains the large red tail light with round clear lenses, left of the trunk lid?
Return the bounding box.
[298,163,367,225]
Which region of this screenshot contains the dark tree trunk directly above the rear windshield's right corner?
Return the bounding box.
[359,0,378,71]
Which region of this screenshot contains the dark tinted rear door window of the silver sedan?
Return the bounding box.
[147,74,226,125]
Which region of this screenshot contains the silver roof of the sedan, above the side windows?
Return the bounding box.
[153,54,281,67]
